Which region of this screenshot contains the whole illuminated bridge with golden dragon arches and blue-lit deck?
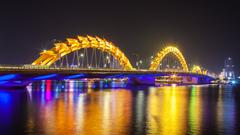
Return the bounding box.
[0,36,215,87]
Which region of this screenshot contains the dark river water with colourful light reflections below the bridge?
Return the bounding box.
[0,81,240,135]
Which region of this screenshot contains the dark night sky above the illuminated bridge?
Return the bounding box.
[0,1,240,72]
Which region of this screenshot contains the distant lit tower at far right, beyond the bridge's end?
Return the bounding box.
[223,57,235,81]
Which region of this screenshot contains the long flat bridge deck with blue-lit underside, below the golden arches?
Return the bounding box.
[0,67,214,87]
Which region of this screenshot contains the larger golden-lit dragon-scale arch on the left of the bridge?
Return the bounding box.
[32,36,134,70]
